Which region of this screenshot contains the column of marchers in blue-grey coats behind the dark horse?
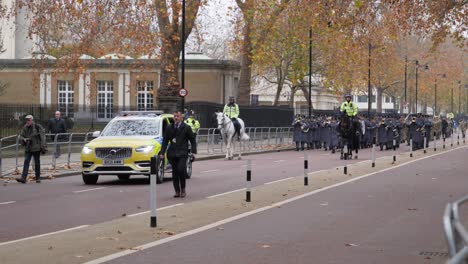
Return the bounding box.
[292,114,468,153]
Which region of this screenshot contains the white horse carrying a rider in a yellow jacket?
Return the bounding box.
[216,112,250,160]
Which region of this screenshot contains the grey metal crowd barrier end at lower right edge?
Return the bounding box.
[443,196,468,264]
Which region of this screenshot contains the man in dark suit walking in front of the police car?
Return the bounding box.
[159,111,197,198]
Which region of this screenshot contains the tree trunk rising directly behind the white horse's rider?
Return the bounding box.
[237,19,252,105]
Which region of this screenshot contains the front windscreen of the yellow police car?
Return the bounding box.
[101,119,159,137]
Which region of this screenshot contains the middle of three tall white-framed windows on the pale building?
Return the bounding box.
[97,81,114,119]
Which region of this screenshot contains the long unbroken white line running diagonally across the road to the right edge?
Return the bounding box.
[84,146,466,264]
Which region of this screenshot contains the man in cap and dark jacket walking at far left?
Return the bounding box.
[16,115,47,183]
